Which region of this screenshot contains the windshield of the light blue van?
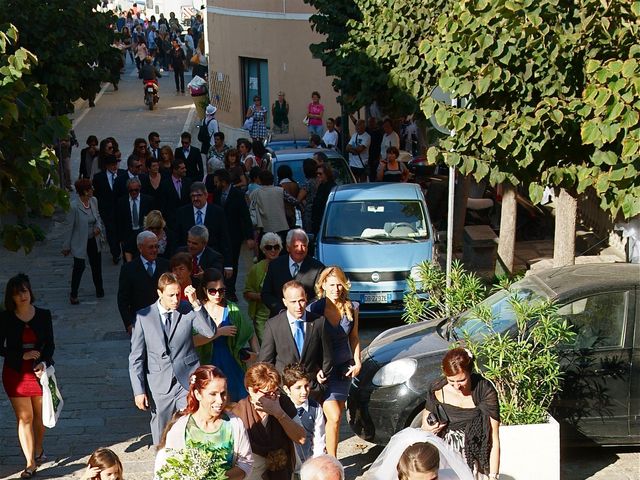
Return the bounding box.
[323,200,429,243]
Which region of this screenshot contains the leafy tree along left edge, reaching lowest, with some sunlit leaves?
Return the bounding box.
[0,25,70,252]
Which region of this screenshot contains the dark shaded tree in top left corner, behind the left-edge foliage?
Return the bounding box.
[0,0,120,115]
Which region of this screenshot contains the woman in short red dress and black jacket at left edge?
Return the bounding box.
[0,273,55,478]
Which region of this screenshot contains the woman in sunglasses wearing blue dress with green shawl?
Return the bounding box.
[194,268,260,402]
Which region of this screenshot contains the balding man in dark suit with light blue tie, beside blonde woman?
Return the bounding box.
[258,280,331,390]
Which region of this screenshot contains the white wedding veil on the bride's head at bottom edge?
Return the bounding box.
[364,428,474,480]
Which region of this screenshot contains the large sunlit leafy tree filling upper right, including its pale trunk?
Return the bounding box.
[314,0,640,264]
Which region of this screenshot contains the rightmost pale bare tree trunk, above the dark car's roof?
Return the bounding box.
[553,188,578,267]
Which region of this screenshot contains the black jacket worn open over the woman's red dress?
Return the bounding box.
[0,307,55,371]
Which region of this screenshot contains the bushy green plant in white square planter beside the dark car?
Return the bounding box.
[463,291,575,480]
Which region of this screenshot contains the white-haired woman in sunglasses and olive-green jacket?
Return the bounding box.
[244,232,282,342]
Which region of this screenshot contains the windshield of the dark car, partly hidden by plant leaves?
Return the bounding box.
[453,279,548,340]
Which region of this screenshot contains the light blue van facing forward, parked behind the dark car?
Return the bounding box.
[315,183,435,317]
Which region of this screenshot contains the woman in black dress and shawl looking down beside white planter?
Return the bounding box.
[422,348,500,479]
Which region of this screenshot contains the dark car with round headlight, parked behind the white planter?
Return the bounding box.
[347,264,640,445]
